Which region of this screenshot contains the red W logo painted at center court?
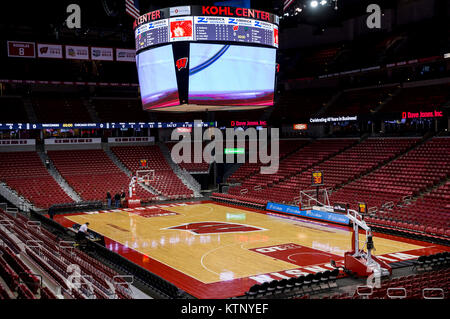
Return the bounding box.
[165,221,266,235]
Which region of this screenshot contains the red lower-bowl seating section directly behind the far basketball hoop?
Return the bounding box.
[111,145,194,198]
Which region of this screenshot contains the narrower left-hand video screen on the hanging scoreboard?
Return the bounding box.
[136,45,180,110]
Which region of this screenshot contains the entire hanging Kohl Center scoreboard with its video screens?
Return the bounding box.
[133,6,279,112]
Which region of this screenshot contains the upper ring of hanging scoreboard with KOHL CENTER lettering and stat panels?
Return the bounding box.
[135,6,279,52]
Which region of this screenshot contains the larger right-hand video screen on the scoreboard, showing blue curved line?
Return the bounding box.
[189,43,276,106]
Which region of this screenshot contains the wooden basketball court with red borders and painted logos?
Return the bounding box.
[53,202,447,298]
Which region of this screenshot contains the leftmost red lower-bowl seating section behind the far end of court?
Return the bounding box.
[0,152,73,209]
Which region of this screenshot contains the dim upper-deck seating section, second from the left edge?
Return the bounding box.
[32,96,92,123]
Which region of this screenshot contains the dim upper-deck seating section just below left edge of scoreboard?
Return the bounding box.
[91,98,148,122]
